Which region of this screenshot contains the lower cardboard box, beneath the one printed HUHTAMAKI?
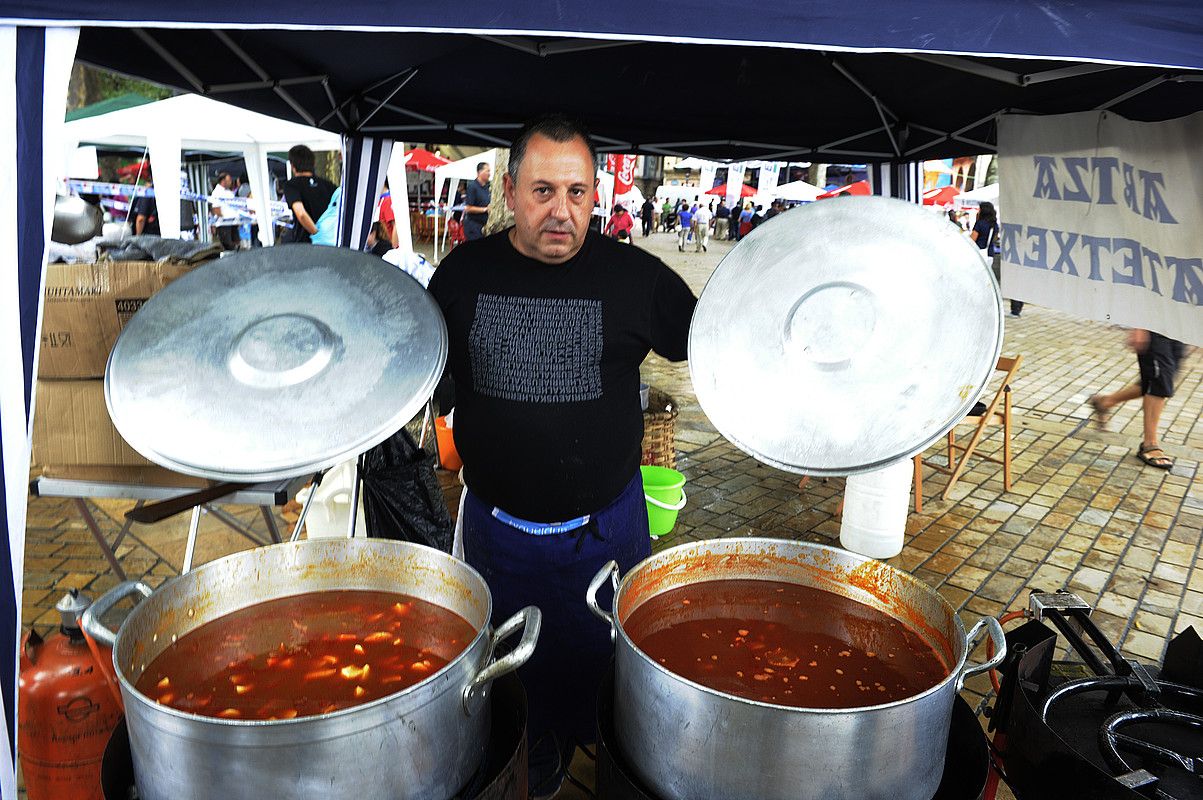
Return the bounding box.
[34,380,150,468]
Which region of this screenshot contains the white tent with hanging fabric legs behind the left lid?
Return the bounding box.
[64,95,342,244]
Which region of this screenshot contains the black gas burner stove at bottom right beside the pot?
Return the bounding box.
[991,592,1203,800]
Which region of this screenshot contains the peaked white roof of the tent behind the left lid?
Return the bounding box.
[64,95,342,152]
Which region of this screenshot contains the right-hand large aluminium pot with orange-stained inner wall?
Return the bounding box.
[587,539,1006,800]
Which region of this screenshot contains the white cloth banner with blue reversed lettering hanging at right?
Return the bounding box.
[998,112,1203,345]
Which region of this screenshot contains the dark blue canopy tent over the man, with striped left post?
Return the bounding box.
[0,0,1203,796]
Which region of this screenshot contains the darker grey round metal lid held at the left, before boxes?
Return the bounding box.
[105,244,448,481]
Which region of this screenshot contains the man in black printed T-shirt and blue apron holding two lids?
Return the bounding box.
[429,115,697,796]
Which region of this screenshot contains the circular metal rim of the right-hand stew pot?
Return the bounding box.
[614,537,968,716]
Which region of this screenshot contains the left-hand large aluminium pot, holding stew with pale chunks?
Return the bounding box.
[83,539,541,800]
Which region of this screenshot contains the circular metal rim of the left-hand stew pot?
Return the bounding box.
[113,539,493,729]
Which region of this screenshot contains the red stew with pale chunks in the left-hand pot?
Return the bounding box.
[135,589,476,719]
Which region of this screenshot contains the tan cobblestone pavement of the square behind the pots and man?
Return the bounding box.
[23,224,1203,798]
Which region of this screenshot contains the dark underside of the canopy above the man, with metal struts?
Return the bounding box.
[72,28,1203,161]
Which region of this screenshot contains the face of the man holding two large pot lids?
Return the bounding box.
[504,136,597,263]
